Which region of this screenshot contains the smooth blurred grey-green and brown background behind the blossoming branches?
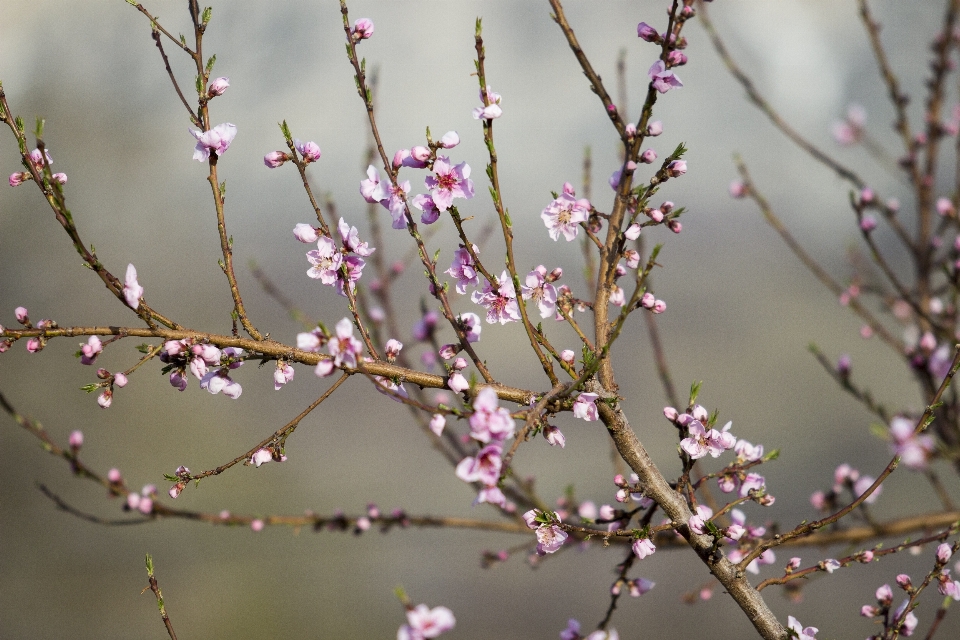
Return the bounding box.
[0,0,960,639]
